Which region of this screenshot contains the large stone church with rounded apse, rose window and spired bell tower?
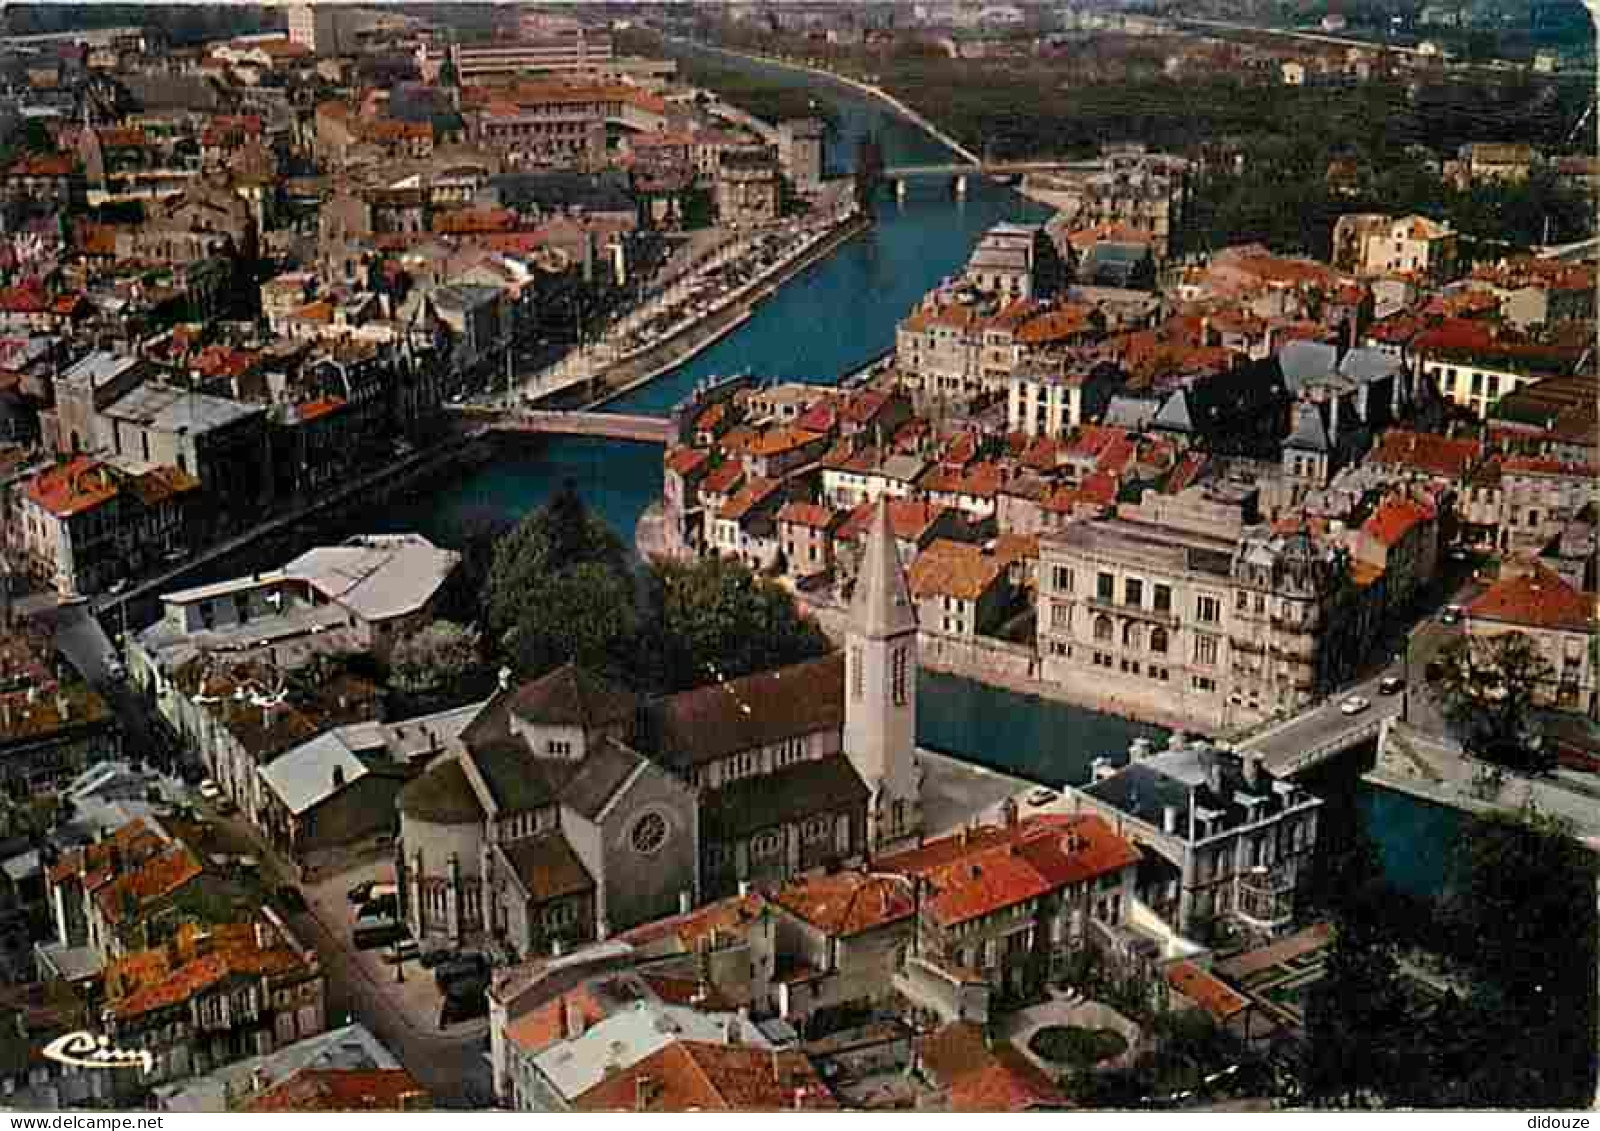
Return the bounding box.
[395,502,922,958]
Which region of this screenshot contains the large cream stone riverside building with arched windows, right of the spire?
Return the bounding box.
[1038,486,1360,729]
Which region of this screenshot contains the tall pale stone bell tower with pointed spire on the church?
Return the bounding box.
[845,498,922,853]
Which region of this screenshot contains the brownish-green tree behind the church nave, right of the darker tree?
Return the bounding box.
[654,558,829,691]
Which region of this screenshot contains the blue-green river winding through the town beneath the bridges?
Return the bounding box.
[378,44,1461,894]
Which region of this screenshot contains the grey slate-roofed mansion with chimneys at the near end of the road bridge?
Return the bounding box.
[1067,737,1322,937]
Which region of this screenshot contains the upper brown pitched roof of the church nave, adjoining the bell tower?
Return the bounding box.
[648,653,845,765]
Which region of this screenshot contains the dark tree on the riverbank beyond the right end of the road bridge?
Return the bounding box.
[1429,632,1555,766]
